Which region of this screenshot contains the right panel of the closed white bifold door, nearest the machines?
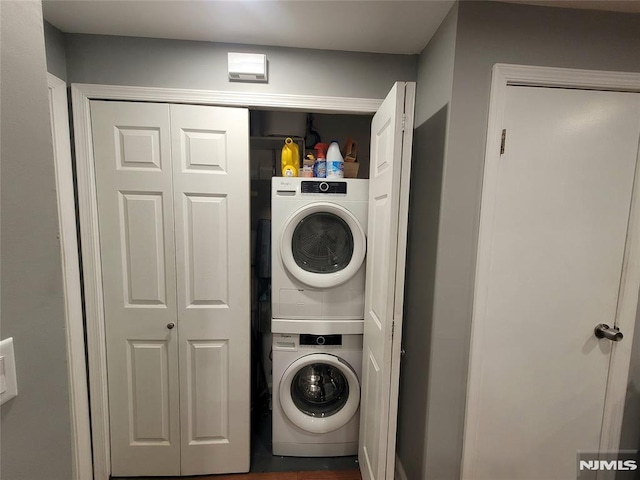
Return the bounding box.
[171,105,251,475]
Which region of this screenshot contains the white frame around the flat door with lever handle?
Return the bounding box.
[461,63,640,478]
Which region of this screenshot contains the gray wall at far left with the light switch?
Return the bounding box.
[0,1,72,480]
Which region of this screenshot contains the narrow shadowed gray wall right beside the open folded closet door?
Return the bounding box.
[396,1,458,479]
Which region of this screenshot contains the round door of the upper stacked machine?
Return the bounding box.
[280,202,367,288]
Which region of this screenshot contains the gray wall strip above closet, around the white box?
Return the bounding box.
[65,34,417,98]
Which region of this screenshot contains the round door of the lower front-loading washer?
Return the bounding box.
[280,353,360,433]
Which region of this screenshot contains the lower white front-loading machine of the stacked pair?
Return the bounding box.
[273,334,362,457]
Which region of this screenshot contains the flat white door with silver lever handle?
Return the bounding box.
[463,86,640,480]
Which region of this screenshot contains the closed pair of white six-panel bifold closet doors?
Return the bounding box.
[91,101,250,476]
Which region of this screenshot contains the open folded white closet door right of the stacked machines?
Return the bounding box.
[358,82,415,480]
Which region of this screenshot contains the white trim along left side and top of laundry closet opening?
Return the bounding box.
[74,83,382,480]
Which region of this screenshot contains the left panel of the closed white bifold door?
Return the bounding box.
[91,101,180,476]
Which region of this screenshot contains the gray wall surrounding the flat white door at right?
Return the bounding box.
[422,2,640,480]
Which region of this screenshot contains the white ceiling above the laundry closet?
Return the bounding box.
[42,0,640,54]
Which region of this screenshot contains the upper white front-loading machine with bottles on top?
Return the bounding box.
[271,177,369,334]
